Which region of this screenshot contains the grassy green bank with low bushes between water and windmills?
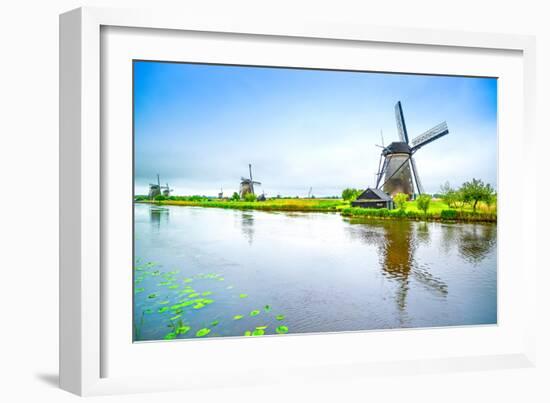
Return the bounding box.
[138,199,497,222]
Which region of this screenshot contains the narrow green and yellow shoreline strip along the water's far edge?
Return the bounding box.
[134,199,498,223]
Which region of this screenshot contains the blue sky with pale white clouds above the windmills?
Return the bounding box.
[134,61,497,197]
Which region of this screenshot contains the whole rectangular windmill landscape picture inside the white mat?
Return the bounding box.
[132,60,498,342]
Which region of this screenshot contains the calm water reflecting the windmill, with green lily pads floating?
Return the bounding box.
[134,204,497,340]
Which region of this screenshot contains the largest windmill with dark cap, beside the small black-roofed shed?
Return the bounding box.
[376,101,449,197]
